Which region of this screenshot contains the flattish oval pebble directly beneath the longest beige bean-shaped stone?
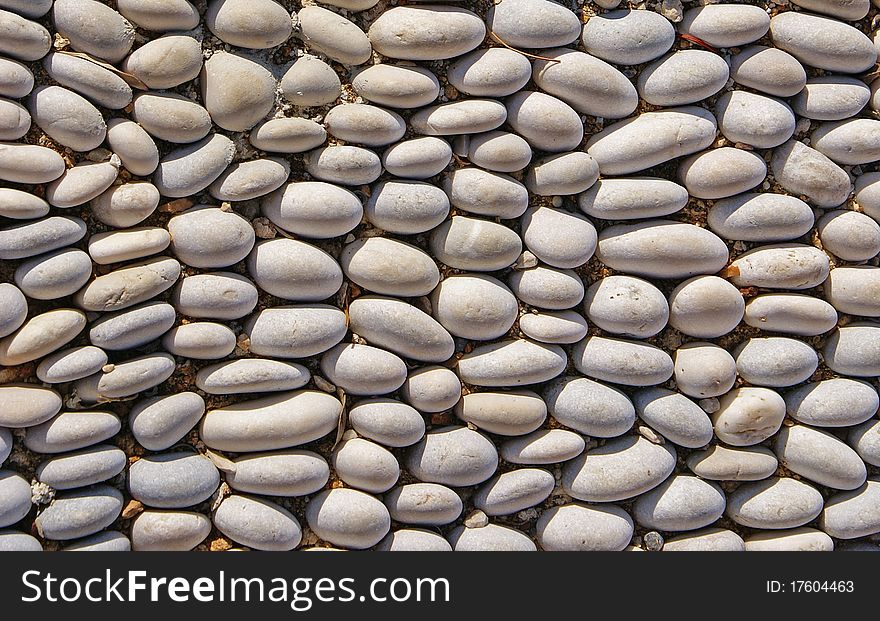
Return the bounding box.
[224,450,330,497]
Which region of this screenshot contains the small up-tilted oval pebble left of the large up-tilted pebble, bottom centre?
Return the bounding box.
[473,468,556,516]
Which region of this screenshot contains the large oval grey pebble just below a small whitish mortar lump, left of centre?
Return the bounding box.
[249,239,342,302]
